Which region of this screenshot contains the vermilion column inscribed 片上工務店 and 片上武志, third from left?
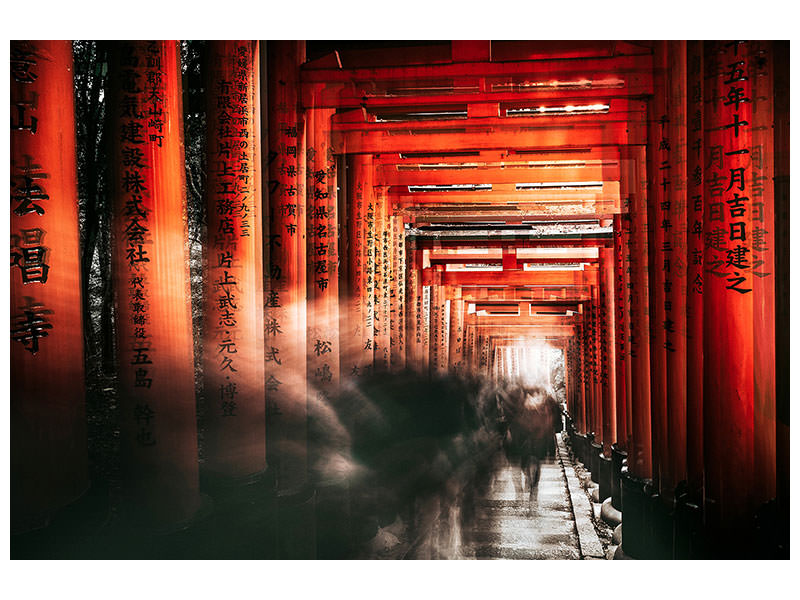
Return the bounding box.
[203,41,266,478]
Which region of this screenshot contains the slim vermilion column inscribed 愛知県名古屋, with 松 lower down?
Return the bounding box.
[306,108,339,404]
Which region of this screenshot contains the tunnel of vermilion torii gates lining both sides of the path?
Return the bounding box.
[10,41,789,556]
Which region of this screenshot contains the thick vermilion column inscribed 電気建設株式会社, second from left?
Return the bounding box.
[108,42,200,527]
